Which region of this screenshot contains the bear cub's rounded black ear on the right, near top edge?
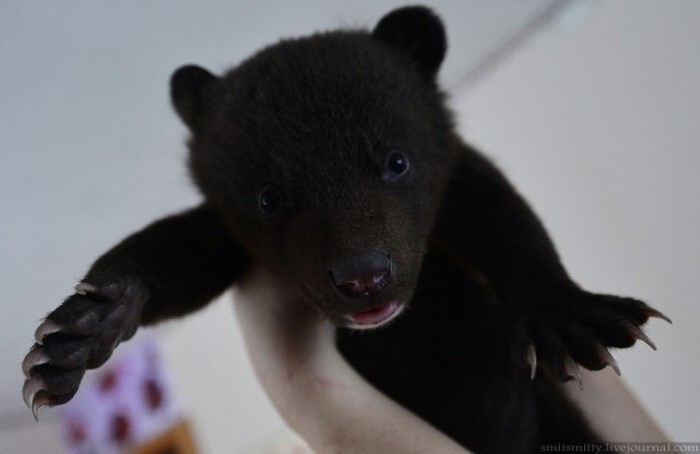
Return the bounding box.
[372,6,447,77]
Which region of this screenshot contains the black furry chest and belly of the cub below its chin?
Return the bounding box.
[338,253,539,452]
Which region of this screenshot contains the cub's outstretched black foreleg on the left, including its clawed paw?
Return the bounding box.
[22,205,249,417]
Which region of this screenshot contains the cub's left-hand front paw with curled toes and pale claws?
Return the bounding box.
[22,278,150,418]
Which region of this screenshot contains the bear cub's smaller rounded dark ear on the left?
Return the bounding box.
[170,65,219,132]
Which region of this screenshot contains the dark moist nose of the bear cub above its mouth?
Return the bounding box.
[331,251,392,296]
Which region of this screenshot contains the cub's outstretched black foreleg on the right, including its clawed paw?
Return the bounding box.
[432,146,670,383]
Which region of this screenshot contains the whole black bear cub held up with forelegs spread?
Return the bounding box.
[23,6,665,453]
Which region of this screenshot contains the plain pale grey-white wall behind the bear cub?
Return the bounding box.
[0,0,700,453]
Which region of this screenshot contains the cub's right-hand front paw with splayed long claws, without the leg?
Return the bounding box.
[514,288,671,388]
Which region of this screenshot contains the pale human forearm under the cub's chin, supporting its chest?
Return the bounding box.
[234,270,465,453]
